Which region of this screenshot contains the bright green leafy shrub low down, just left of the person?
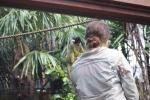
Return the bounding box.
[45,57,76,100]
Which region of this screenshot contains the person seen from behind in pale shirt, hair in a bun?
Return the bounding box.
[71,21,139,100]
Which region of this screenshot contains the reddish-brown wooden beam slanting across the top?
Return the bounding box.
[0,0,150,24]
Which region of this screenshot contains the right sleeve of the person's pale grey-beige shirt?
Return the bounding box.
[118,53,139,100]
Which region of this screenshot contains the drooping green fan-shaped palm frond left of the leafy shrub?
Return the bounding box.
[14,51,57,77]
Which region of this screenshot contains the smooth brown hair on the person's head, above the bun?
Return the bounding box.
[85,21,110,42]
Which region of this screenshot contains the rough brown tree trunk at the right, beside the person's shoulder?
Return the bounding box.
[126,23,150,100]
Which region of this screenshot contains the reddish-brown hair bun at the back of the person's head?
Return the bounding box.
[86,35,100,49]
